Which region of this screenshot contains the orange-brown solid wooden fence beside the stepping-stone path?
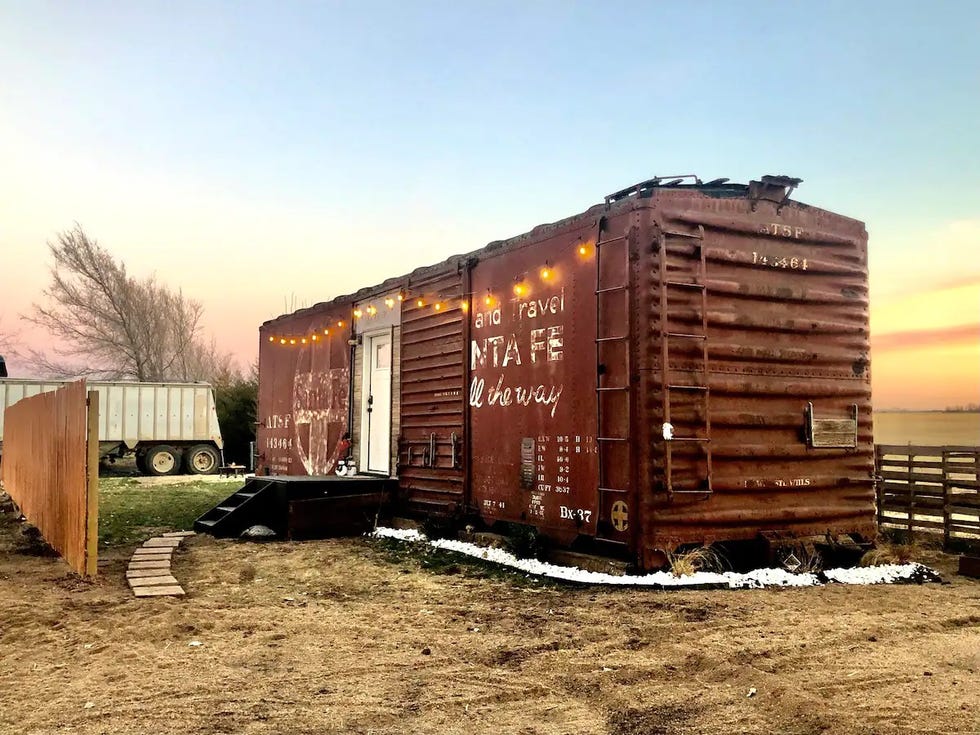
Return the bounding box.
[0,380,99,577]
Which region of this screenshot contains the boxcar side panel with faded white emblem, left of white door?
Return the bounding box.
[256,310,350,475]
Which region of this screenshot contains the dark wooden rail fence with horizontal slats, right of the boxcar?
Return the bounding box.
[875,444,980,546]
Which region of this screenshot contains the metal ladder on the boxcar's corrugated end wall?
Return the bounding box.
[660,225,712,495]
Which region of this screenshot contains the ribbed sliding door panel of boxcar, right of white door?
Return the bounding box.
[398,264,468,514]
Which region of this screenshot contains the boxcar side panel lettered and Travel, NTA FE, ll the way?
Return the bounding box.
[468,217,600,541]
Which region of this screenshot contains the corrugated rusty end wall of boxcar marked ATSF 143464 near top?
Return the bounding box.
[640,192,874,553]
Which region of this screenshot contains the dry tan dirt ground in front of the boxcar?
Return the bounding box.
[0,515,980,735]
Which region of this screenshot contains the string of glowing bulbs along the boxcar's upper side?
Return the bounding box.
[267,242,594,347]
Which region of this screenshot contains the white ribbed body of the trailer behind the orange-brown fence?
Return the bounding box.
[0,378,224,449]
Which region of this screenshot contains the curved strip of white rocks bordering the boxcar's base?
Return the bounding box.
[370,527,939,589]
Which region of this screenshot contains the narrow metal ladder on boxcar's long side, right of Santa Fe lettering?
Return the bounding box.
[595,218,632,544]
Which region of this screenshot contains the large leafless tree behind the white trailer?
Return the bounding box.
[25,223,230,381]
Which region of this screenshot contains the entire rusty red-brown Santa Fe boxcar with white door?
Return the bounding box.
[257,176,875,568]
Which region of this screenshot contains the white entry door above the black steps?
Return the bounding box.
[361,334,391,475]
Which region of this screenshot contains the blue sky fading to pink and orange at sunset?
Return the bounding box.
[0,0,980,408]
